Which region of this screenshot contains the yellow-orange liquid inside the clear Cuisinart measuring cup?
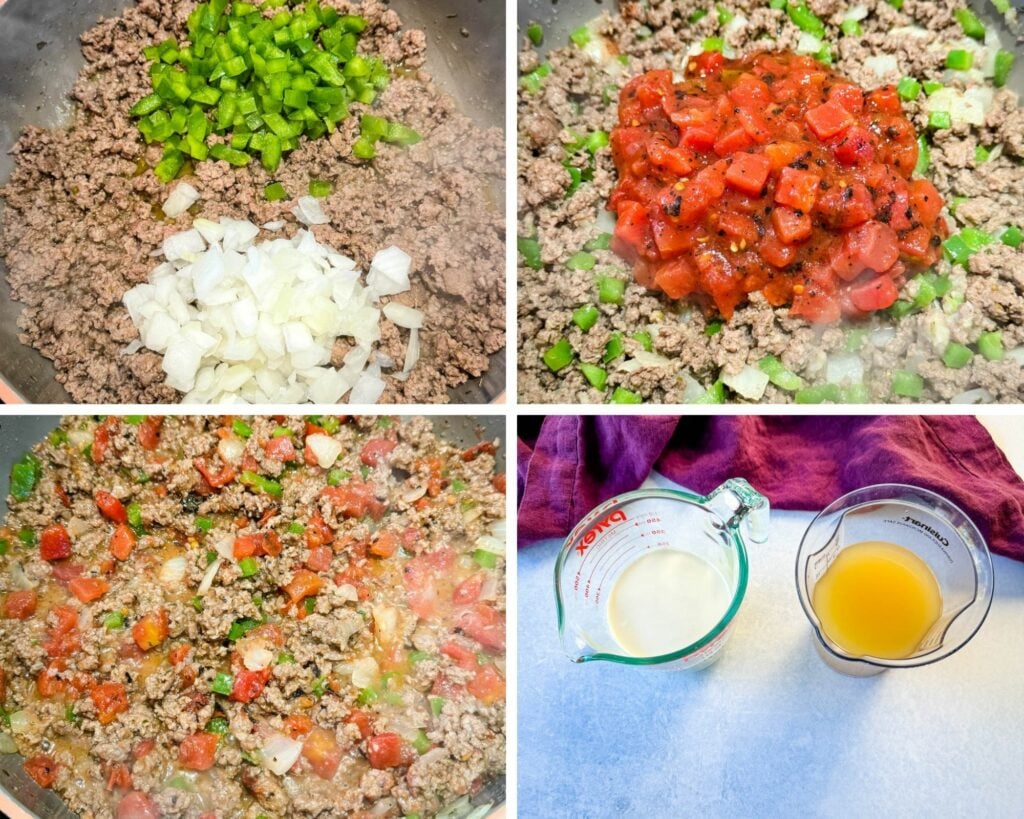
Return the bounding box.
[811,541,942,659]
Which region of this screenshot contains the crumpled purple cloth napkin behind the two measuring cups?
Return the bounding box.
[518,416,1024,560]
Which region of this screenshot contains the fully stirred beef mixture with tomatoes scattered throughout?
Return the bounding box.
[0,416,505,819]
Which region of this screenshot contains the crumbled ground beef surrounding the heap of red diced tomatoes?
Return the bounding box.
[518,0,1024,403]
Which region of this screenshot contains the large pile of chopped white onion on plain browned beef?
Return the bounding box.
[121,217,423,403]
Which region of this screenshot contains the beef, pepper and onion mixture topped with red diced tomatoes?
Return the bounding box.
[518,0,1024,403]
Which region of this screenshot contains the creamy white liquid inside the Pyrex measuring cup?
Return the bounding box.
[608,549,732,657]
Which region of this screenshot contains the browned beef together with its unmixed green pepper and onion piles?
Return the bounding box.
[0,0,505,403]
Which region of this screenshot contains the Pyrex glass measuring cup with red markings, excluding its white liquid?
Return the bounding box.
[555,478,768,669]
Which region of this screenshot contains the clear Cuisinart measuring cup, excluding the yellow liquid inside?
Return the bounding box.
[797,483,994,677]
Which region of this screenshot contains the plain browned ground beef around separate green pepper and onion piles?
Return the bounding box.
[0,0,505,403]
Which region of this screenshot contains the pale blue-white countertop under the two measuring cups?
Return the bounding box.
[517,456,1024,818]
